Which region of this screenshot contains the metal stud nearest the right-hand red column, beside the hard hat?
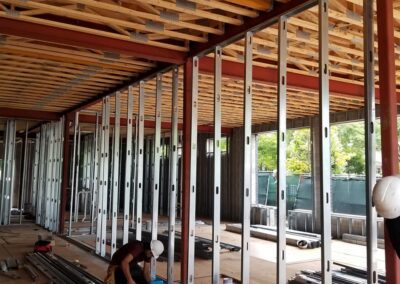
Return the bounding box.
[363,0,378,284]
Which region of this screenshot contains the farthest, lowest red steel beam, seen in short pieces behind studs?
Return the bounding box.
[79,114,232,135]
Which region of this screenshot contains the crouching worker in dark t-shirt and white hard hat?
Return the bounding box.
[104,240,164,284]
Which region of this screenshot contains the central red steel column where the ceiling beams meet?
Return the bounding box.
[181,60,193,283]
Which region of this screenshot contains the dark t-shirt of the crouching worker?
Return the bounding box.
[110,241,151,265]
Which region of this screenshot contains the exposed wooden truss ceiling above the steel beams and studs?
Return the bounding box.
[0,0,400,127]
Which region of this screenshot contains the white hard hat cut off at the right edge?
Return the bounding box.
[372,176,400,219]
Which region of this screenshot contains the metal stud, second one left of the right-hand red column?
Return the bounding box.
[319,0,332,284]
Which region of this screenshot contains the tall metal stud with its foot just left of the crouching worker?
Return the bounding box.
[100,96,110,257]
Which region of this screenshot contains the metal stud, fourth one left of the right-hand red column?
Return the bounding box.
[241,32,253,284]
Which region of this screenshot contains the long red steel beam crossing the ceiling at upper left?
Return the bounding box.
[0,17,186,64]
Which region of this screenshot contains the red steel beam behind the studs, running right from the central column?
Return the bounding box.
[199,57,400,102]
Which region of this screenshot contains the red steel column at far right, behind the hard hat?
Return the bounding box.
[376,0,400,284]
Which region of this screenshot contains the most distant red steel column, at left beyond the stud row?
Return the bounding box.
[58,116,71,234]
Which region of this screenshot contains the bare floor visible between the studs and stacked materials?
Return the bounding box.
[0,219,384,284]
